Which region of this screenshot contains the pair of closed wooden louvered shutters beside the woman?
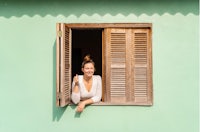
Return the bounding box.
[104,28,152,105]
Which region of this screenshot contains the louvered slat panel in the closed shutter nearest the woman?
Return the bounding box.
[110,30,126,102]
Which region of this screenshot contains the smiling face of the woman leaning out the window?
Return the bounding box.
[82,63,94,77]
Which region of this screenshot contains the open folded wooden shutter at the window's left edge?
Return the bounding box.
[56,23,71,107]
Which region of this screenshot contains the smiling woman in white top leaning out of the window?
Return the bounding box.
[71,55,102,112]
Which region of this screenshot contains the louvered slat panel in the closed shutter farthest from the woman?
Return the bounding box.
[133,29,150,103]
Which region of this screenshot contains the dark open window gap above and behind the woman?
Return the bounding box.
[72,29,102,77]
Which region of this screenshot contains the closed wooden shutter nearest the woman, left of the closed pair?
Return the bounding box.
[105,28,130,103]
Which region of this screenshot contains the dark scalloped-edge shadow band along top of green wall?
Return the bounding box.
[0,0,199,18]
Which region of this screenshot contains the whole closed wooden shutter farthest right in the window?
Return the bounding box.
[131,29,152,105]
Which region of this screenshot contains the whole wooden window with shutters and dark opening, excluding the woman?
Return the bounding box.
[56,23,153,107]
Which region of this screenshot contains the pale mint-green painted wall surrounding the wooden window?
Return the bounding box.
[0,0,199,132]
